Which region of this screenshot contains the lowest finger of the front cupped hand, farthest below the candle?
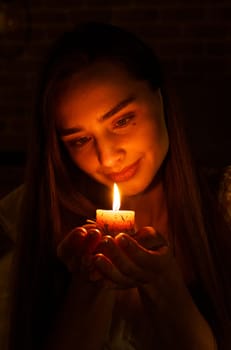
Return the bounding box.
[94,254,134,288]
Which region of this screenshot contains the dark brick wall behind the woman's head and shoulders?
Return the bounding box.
[0,0,231,197]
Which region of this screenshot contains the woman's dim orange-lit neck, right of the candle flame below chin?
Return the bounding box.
[123,181,169,237]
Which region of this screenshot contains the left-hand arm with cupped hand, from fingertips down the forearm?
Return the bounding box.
[46,224,115,350]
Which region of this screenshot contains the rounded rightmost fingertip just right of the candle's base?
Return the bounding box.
[133,226,168,250]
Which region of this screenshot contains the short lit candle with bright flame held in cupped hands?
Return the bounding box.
[96,184,135,236]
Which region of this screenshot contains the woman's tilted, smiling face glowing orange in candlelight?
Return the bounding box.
[56,63,169,196]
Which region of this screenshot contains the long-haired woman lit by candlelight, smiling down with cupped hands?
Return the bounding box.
[3,23,231,350]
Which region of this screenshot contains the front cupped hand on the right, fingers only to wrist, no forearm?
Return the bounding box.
[89,227,171,288]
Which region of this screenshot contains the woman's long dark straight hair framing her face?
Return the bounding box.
[10,23,231,350]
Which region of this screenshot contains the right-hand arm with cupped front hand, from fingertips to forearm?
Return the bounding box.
[88,227,217,350]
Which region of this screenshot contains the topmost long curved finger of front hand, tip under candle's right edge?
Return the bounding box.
[115,233,169,271]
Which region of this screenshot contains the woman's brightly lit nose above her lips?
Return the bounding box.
[96,140,124,168]
